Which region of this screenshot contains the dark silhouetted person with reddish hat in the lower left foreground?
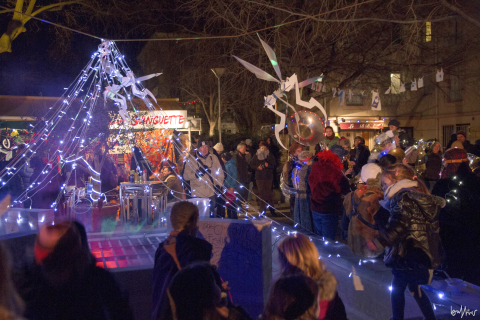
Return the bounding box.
[17,221,133,320]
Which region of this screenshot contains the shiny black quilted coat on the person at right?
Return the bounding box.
[375,189,445,270]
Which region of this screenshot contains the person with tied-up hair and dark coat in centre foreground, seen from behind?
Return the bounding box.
[151,201,212,319]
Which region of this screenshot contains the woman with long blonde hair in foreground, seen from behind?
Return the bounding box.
[278,233,347,320]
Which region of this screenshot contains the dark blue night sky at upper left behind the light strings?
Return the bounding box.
[0,19,143,96]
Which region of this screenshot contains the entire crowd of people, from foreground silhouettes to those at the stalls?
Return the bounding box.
[0,120,480,319]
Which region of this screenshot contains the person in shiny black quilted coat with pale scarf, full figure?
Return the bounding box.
[367,164,445,320]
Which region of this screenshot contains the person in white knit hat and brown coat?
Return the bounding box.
[342,163,390,258]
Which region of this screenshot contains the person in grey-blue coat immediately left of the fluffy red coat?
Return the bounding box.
[292,151,314,233]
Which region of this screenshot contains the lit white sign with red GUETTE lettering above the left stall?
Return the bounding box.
[109,110,187,130]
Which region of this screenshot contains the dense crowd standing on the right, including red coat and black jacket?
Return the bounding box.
[283,120,480,319]
